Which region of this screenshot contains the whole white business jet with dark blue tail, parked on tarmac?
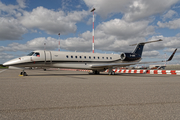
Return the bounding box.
[3,39,177,76]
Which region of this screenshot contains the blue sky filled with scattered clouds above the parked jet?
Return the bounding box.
[0,0,180,64]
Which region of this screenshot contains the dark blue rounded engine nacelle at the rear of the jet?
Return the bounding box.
[120,53,141,61]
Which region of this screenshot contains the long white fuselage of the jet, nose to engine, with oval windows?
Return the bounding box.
[4,50,122,70]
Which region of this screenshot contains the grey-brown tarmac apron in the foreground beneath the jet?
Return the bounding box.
[0,69,180,120]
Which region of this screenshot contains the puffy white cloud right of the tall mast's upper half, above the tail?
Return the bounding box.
[97,19,154,39]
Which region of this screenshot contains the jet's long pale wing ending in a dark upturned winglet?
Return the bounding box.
[90,48,177,68]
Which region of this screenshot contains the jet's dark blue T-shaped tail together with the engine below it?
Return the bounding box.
[120,39,162,61]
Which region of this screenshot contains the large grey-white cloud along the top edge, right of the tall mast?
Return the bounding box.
[84,0,179,21]
